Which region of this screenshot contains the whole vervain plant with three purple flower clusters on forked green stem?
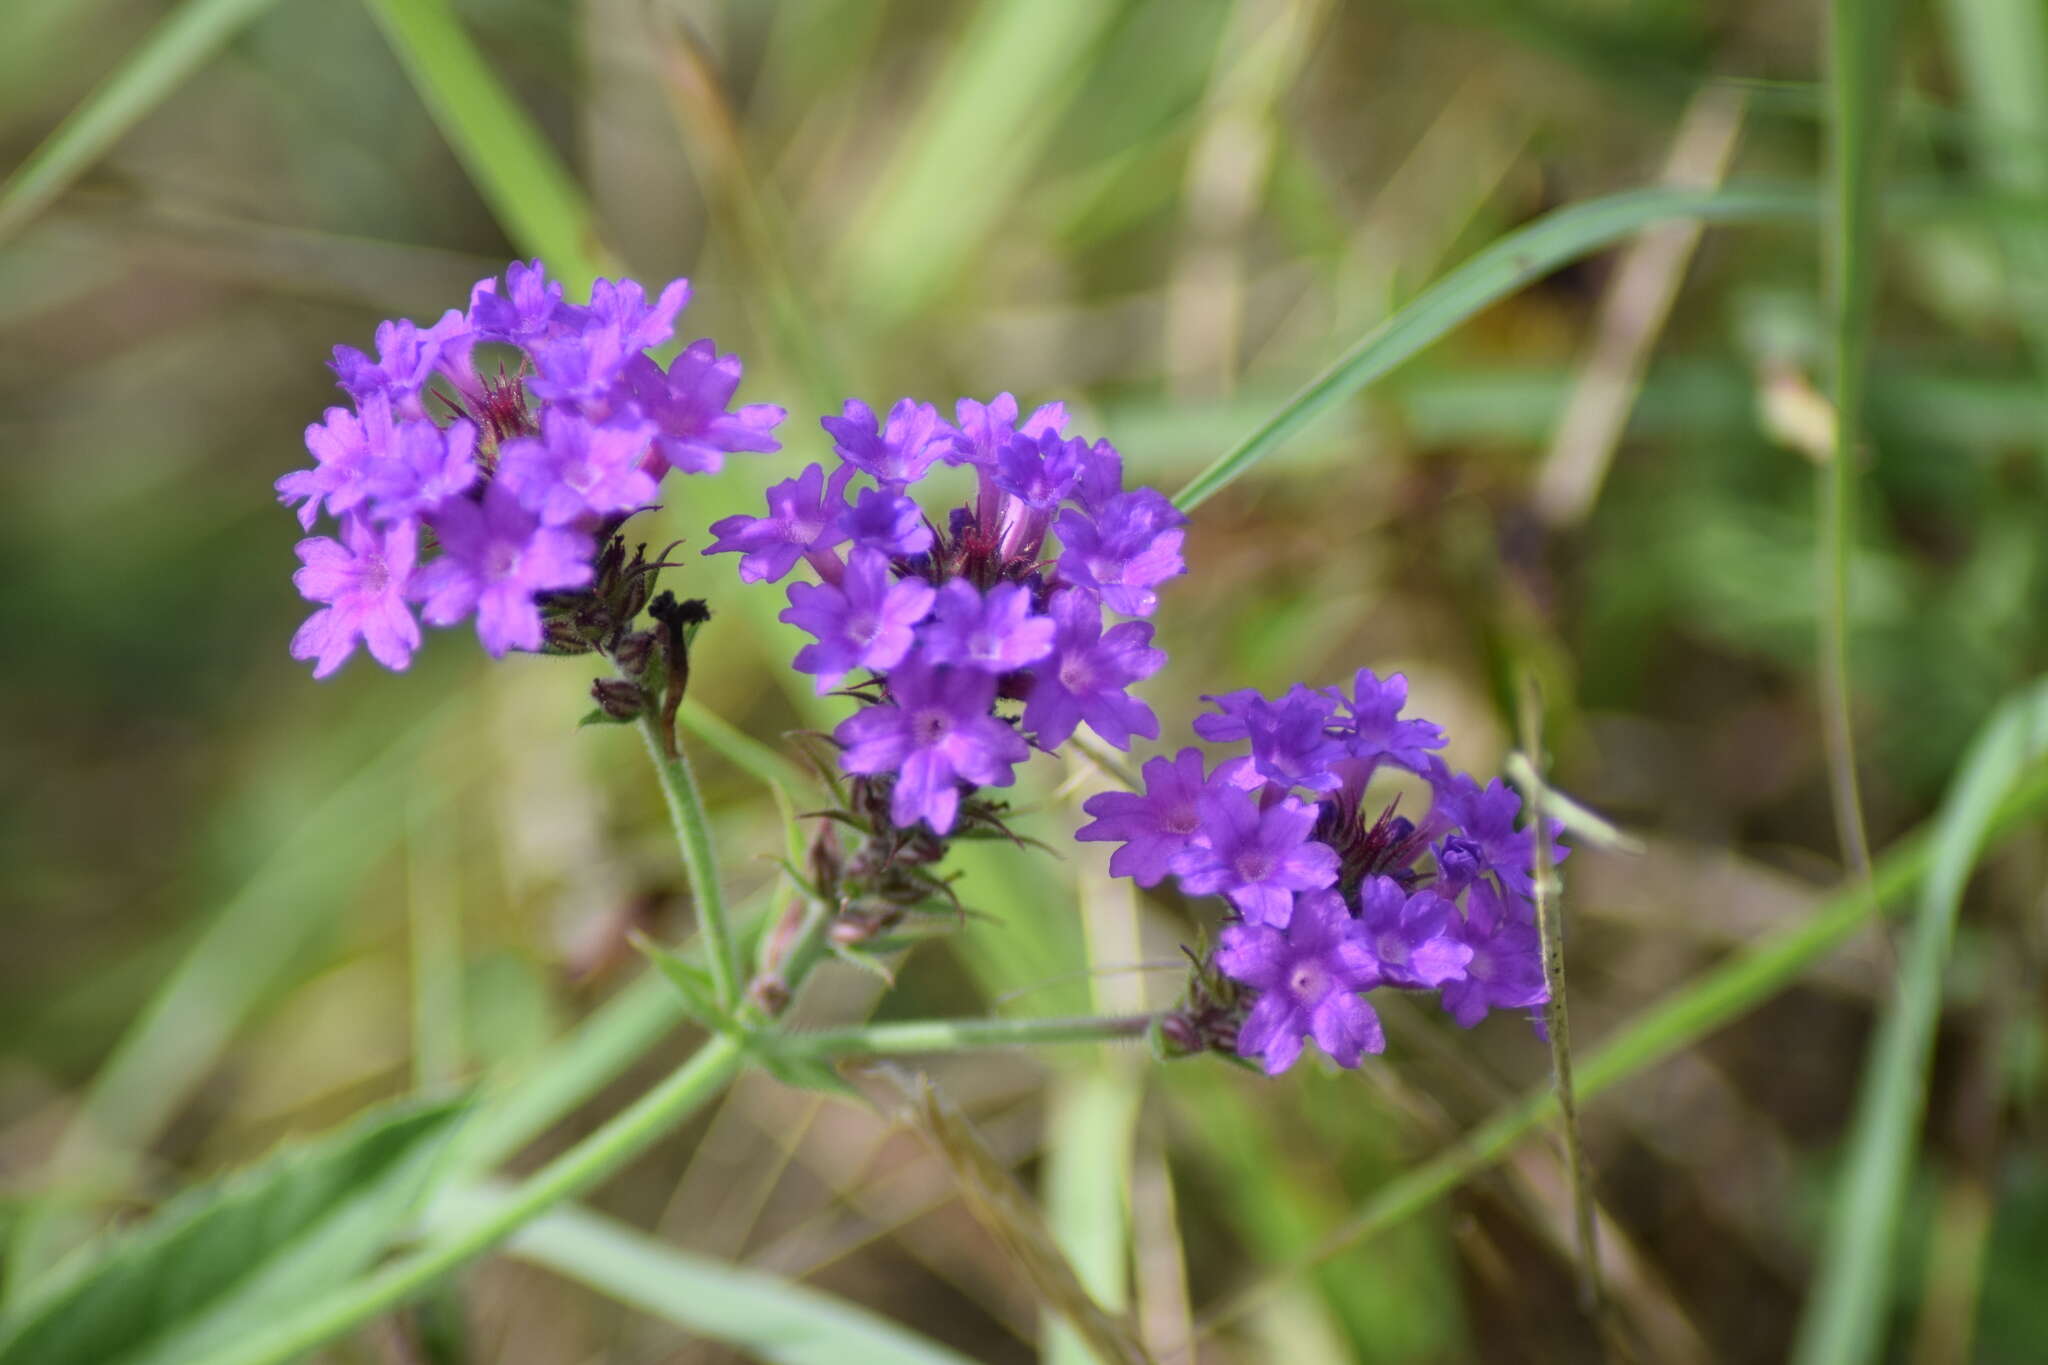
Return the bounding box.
[172,262,1565,1361]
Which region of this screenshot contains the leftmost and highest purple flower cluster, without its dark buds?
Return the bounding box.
[288,262,782,677]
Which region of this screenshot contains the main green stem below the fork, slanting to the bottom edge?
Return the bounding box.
[197,1033,745,1365]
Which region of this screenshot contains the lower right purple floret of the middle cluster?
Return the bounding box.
[1024,587,1165,749]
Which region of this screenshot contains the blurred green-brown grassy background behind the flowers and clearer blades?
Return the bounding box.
[12,0,2048,1363]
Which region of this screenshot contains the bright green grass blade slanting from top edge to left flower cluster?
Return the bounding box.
[362,0,618,293]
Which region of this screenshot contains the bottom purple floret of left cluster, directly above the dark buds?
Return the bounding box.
[412,483,596,657]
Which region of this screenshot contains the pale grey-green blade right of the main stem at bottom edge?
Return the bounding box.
[451,1191,969,1365]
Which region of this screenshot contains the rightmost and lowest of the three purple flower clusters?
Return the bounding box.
[1075,669,1565,1074]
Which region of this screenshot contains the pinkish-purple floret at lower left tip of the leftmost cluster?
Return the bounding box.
[291,518,420,677]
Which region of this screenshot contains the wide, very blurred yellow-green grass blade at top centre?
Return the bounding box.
[834,0,1122,327]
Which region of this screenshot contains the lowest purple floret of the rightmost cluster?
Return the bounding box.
[1217,892,1386,1076]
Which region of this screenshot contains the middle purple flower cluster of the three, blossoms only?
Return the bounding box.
[705,393,1184,835]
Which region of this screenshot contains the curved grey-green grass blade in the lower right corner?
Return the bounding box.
[1792,684,2048,1365]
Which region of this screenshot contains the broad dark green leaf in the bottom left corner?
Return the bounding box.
[0,1101,463,1365]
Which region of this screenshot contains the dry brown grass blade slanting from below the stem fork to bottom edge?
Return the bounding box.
[891,1072,1155,1365]
